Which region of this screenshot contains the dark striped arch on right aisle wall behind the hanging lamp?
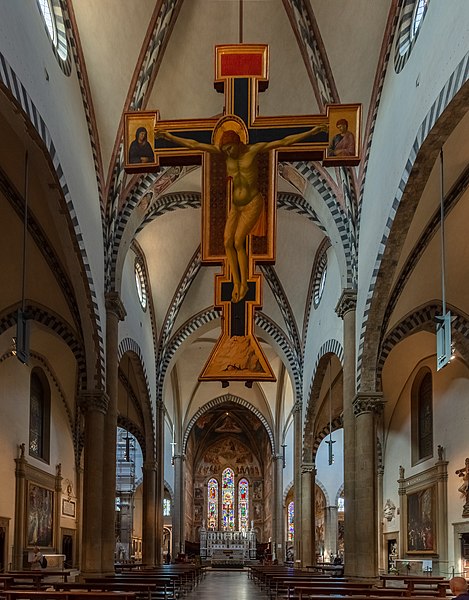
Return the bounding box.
[375,303,469,390]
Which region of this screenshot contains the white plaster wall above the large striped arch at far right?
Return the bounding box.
[357,0,469,332]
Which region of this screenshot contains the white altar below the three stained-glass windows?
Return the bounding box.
[200,527,256,566]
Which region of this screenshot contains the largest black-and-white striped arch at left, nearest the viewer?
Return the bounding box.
[0,52,106,389]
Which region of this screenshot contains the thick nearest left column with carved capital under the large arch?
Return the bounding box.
[79,390,110,577]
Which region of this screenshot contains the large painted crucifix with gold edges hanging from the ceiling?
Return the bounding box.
[125,44,360,381]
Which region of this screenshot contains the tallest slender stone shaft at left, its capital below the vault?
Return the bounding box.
[101,292,126,573]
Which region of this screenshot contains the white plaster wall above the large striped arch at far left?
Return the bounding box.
[0,0,105,316]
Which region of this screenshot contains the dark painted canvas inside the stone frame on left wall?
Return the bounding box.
[26,481,54,547]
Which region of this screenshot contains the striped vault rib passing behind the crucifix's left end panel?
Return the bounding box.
[105,0,182,291]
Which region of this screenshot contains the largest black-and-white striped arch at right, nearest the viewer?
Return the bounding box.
[357,52,469,391]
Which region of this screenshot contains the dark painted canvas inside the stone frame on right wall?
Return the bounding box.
[407,485,437,554]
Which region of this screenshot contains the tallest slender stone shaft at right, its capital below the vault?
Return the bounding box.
[335,289,357,576]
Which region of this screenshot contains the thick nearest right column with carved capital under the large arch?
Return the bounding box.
[352,392,383,577]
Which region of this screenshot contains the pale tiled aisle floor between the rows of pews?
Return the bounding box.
[184,569,268,600]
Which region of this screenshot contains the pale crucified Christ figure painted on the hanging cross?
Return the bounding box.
[156,124,328,302]
